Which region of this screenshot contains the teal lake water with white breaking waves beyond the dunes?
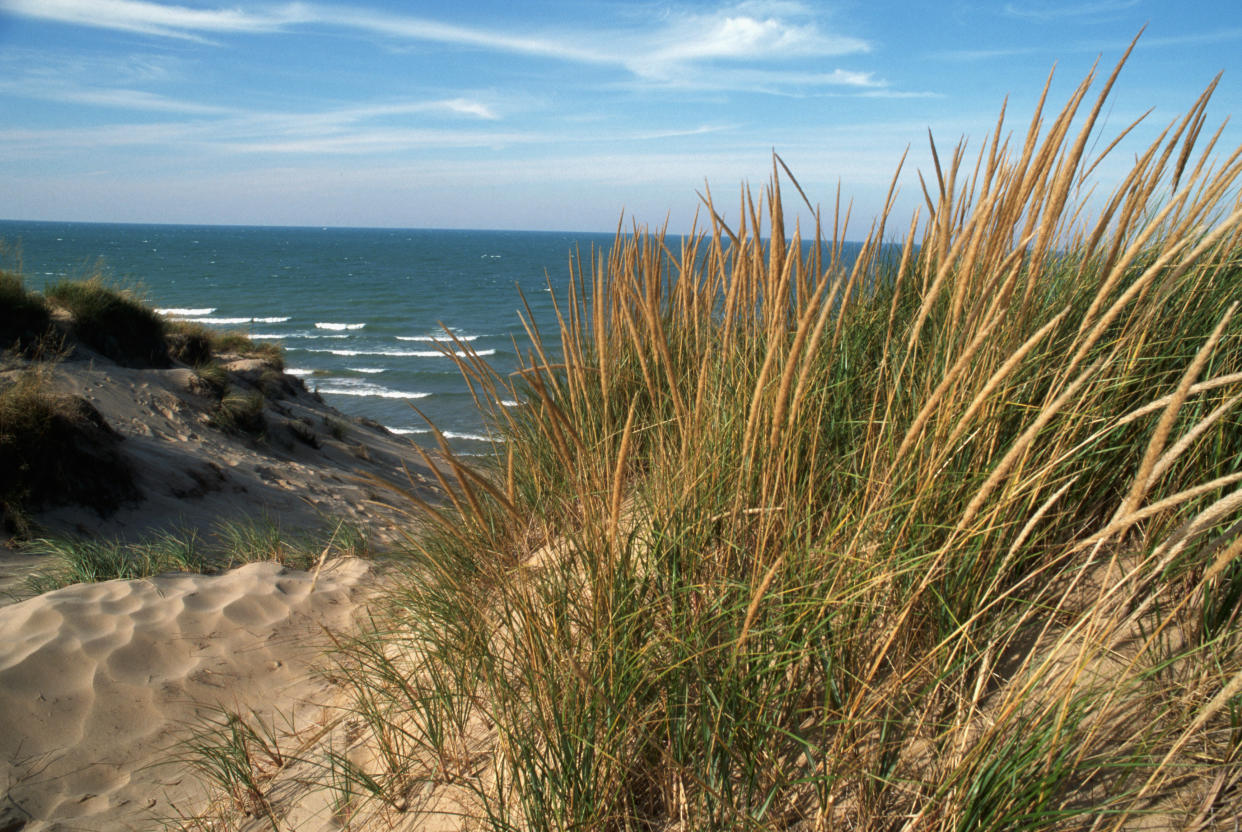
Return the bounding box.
[0,221,612,453]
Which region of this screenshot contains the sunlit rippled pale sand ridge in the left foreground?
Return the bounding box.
[0,559,375,832]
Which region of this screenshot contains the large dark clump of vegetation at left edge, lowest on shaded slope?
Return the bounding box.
[0,370,138,533]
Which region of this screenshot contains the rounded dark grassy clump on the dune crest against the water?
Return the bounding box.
[45,276,169,368]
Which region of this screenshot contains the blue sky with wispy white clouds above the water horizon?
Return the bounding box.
[0,0,1242,238]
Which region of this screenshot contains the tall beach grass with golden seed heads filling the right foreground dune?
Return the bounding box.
[325,47,1242,832]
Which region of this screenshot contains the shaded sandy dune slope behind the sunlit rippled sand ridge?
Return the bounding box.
[0,348,436,605]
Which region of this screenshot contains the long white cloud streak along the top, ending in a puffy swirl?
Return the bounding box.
[0,0,879,89]
